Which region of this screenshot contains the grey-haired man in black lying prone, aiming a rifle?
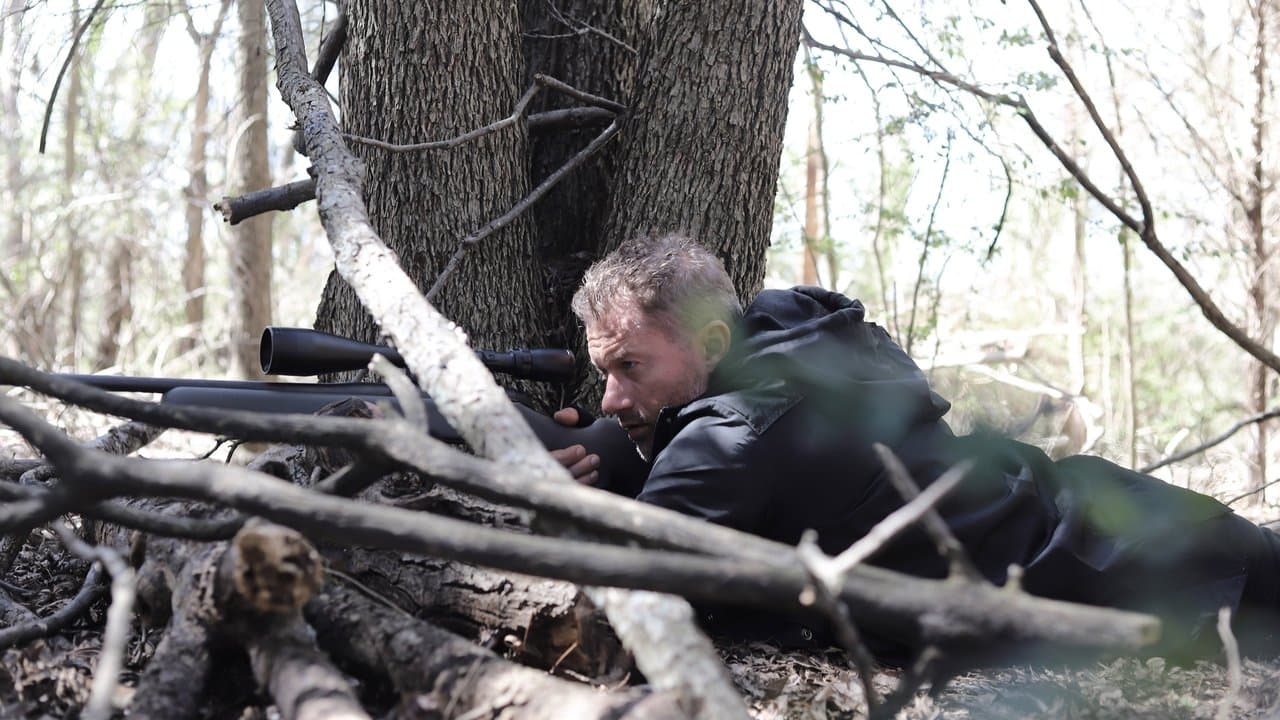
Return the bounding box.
[556,234,1280,652]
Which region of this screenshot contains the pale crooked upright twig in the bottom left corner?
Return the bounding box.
[54,523,137,720]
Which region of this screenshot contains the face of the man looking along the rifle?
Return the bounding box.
[586,304,710,460]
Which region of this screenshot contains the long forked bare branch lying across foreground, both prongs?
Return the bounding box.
[0,384,1158,647]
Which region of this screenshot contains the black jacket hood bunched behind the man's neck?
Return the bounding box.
[709,287,951,423]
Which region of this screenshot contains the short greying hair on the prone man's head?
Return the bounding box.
[572,233,742,332]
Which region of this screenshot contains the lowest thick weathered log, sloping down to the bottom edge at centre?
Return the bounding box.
[305,583,684,720]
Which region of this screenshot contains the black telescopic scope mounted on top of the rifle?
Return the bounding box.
[259,327,573,382]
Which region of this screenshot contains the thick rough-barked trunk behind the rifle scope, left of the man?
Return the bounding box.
[316,0,549,392]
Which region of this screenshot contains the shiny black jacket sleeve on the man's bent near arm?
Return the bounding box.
[636,415,769,533]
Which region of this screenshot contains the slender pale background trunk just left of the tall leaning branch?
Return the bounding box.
[227,0,271,378]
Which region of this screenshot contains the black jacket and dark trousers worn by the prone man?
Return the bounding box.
[606,287,1280,651]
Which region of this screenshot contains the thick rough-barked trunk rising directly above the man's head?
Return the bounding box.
[605,0,801,301]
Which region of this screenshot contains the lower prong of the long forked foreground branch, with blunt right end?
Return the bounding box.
[0,397,1160,650]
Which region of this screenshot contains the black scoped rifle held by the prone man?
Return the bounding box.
[61,327,648,491]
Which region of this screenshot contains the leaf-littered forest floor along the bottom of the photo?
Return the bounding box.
[0,520,1280,720]
